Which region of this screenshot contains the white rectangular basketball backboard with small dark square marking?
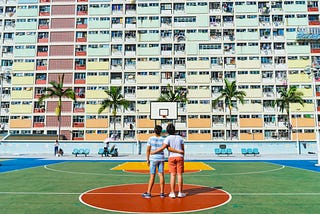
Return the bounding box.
[150,102,178,120]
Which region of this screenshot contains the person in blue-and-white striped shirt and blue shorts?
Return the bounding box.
[142,125,166,198]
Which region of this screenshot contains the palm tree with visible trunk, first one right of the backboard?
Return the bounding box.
[213,79,247,140]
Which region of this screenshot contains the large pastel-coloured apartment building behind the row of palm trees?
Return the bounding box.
[0,0,320,141]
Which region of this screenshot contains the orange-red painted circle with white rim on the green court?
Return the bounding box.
[79,184,231,213]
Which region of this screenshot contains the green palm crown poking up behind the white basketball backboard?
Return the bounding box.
[158,84,188,103]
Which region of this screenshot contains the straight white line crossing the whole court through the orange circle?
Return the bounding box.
[0,192,320,197]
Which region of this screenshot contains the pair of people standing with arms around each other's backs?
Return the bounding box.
[142,124,186,198]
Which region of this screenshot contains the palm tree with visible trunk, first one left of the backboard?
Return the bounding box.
[98,86,129,138]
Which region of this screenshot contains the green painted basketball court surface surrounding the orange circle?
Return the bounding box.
[0,161,320,214]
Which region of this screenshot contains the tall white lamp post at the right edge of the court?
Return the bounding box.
[306,65,320,166]
